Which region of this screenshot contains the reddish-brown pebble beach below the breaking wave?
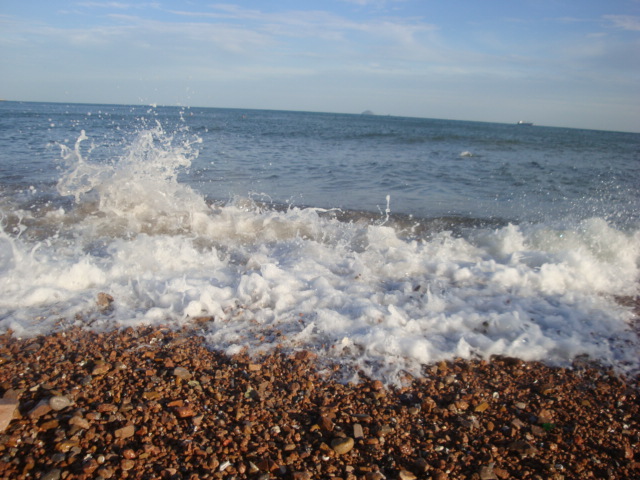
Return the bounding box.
[0,327,640,480]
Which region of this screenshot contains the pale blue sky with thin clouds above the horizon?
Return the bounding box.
[0,0,640,132]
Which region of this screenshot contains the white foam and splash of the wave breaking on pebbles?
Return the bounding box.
[0,127,640,381]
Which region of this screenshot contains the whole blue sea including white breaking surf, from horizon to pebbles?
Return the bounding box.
[0,101,640,383]
